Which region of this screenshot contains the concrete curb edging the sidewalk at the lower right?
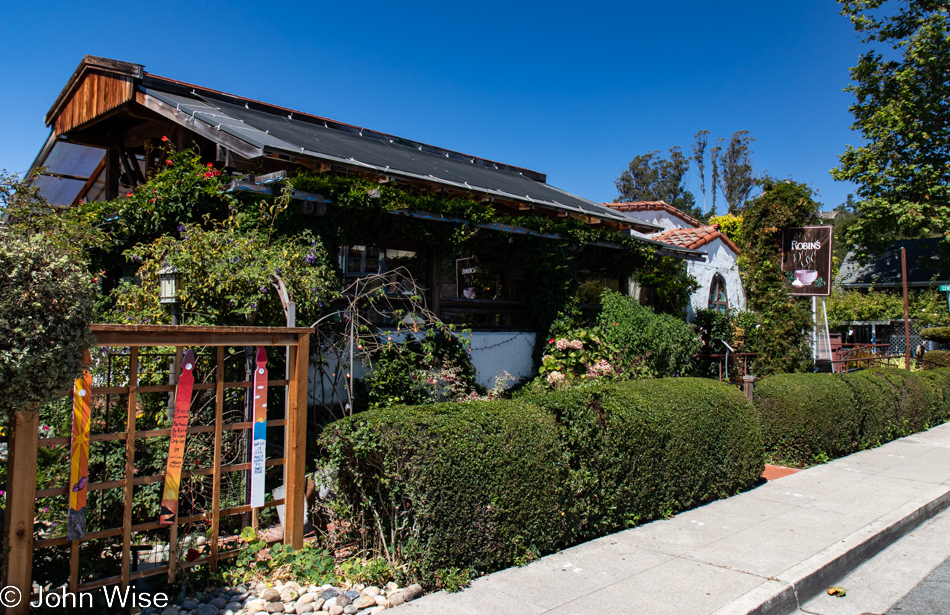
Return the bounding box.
[714,487,950,615]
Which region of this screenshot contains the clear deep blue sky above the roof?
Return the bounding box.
[0,0,863,211]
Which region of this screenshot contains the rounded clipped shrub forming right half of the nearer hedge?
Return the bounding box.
[532,378,763,544]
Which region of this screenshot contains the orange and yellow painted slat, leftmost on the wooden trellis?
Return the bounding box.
[66,350,92,540]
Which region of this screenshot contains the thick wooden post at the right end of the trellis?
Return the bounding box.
[284,335,310,549]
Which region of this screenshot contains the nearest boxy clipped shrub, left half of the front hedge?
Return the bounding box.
[322,400,564,579]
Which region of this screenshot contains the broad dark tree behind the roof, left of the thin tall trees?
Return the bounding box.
[614,145,702,216]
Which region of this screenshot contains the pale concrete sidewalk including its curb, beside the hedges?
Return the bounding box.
[394,423,950,615]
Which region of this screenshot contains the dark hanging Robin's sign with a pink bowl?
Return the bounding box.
[782,226,832,297]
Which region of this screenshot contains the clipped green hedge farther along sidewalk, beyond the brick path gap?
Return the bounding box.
[755,369,950,467]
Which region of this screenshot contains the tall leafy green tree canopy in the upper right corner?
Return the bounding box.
[832,0,950,251]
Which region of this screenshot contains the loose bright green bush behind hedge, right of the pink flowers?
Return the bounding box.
[597,290,700,377]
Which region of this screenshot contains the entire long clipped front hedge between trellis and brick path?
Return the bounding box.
[322,378,764,587]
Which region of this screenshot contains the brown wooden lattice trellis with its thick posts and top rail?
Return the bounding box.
[4,325,313,613]
